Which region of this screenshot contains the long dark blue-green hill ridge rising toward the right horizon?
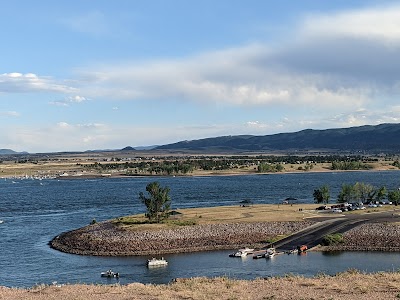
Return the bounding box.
[156,124,400,152]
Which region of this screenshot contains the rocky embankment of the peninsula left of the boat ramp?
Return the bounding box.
[49,221,314,256]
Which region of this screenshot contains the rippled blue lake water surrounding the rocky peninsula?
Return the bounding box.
[0,171,400,287]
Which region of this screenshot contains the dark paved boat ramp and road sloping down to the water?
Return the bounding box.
[266,211,400,251]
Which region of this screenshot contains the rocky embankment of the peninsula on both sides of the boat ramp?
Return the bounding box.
[49,221,400,256]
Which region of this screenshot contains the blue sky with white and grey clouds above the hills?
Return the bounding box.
[0,0,400,153]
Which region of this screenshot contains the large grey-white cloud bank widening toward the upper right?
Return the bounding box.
[74,6,400,111]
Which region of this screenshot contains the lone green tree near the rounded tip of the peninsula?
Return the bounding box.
[139,181,171,223]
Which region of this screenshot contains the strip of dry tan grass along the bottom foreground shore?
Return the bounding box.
[0,271,400,300]
